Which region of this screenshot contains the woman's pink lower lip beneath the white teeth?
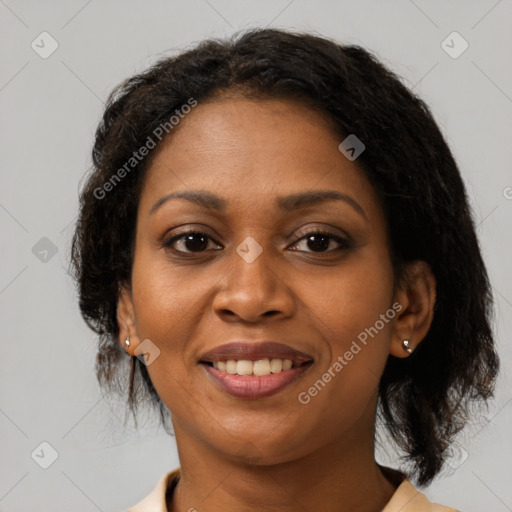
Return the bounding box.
[201,363,311,400]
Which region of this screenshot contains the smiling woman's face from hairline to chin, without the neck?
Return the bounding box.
[122,97,396,464]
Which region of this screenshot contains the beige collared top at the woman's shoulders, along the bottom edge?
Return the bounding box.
[125,468,459,512]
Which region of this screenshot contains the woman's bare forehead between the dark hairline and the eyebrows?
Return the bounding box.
[139,97,377,222]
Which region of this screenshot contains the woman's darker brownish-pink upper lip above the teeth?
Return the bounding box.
[200,341,313,363]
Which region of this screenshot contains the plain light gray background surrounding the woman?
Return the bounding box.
[0,0,512,512]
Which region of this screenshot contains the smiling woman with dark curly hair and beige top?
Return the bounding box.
[72,29,498,512]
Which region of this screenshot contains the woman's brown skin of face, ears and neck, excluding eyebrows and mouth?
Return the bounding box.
[118,95,435,512]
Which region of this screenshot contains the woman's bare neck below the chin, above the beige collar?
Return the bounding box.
[167,404,396,512]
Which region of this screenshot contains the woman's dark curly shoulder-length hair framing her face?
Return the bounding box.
[71,29,499,485]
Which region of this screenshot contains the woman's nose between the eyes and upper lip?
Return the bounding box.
[213,241,295,323]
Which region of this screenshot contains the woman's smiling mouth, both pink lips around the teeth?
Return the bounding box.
[199,341,313,400]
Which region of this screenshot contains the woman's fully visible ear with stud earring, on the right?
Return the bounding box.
[389,260,436,357]
